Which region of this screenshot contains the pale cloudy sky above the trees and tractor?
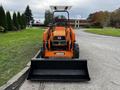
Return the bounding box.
[0,0,120,22]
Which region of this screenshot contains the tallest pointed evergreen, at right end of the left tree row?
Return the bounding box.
[24,5,33,24]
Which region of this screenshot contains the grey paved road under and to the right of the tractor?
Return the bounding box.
[20,29,120,90]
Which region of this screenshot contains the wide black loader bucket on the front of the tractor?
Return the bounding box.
[27,59,90,81]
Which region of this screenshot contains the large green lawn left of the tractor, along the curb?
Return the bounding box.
[0,29,43,86]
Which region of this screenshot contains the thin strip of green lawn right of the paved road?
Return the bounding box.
[85,28,120,37]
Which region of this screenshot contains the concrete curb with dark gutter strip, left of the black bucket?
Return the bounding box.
[0,62,30,90]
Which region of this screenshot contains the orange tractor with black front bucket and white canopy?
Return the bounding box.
[28,6,90,81]
